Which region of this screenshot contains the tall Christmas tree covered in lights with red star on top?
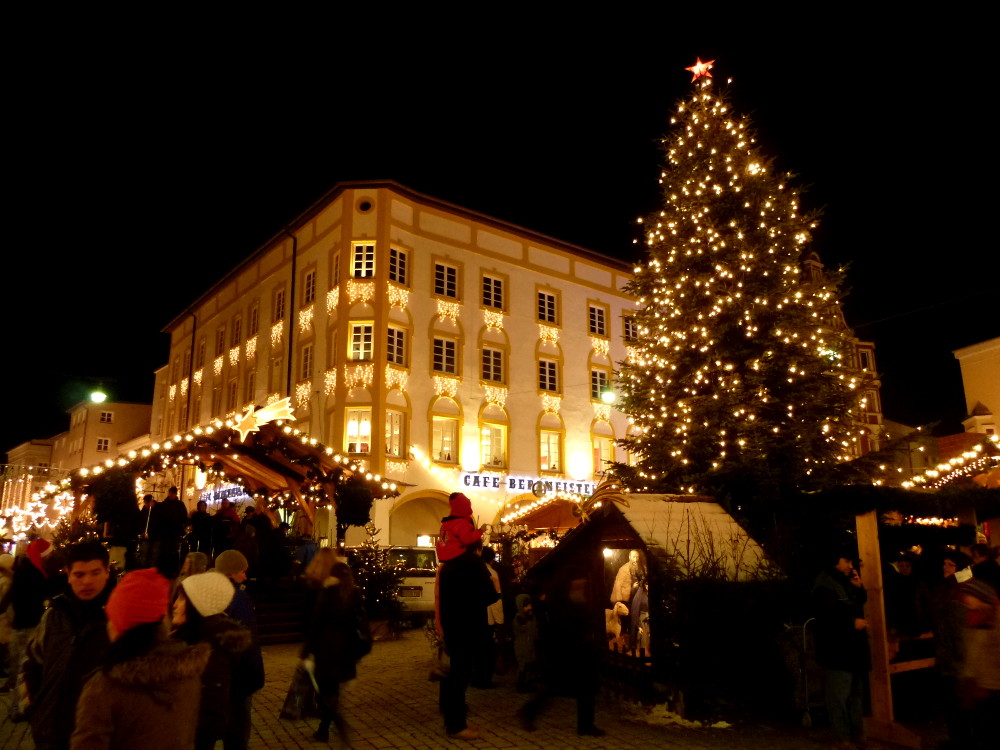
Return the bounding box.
[616,60,859,504]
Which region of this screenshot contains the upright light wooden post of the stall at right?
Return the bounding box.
[855,510,920,748]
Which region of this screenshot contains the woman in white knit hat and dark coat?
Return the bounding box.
[174,570,252,750]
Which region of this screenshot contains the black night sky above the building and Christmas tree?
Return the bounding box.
[0,13,1000,458]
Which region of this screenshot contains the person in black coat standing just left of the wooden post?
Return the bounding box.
[812,552,871,748]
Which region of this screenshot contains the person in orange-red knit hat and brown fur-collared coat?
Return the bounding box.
[70,568,211,750]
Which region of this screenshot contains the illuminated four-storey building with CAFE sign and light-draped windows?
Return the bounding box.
[159,182,634,545]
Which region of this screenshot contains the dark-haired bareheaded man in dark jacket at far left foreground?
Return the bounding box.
[22,541,112,750]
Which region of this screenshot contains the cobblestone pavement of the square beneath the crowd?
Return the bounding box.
[0,630,940,750]
